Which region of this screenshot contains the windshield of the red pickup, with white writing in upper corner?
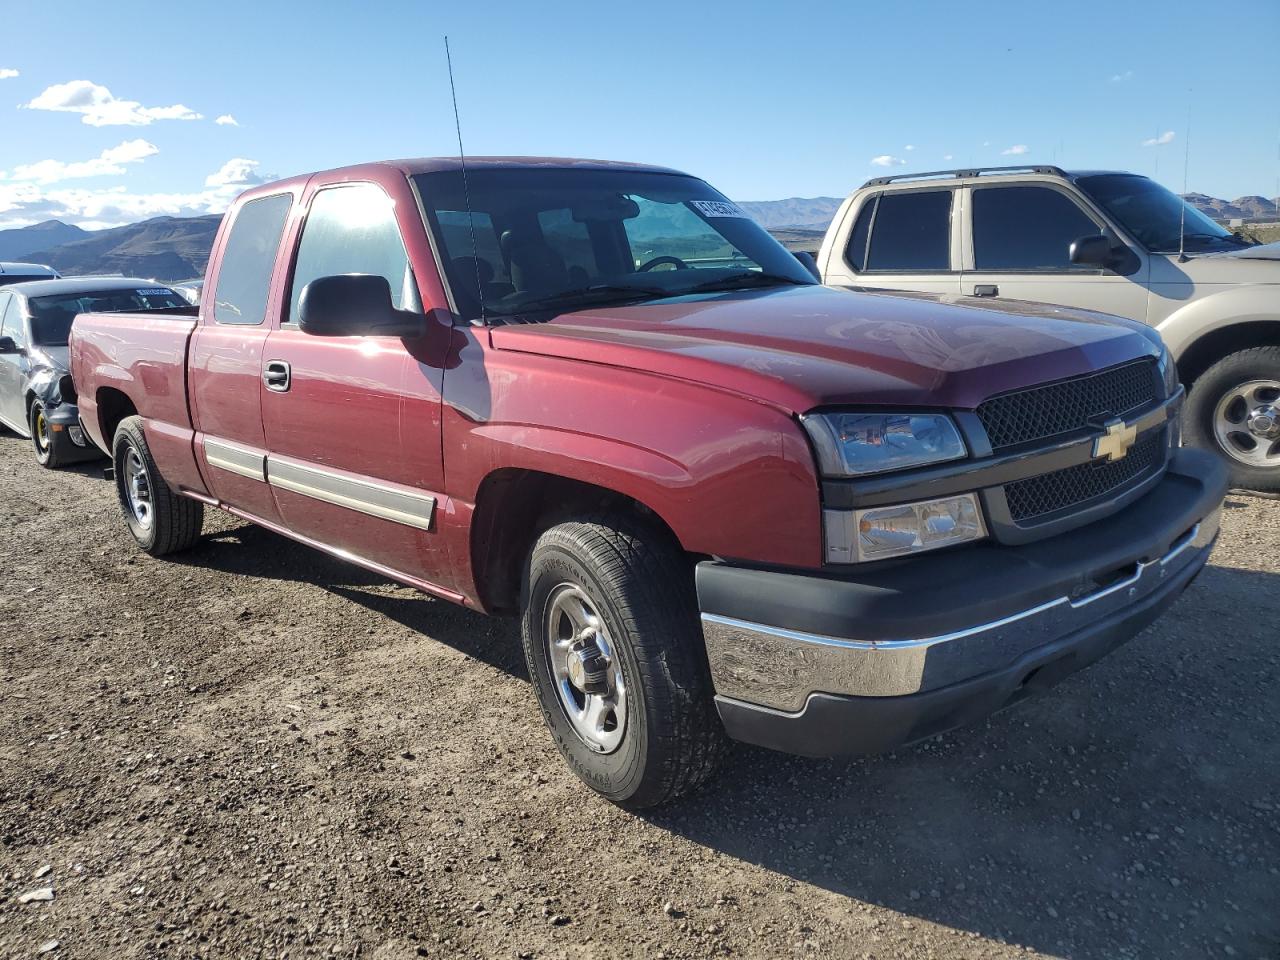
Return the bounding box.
[413,168,814,319]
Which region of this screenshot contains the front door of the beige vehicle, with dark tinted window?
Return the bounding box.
[961,183,1148,320]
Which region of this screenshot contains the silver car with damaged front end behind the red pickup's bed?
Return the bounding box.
[0,276,193,467]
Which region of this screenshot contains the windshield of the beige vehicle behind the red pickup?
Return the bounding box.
[1076,174,1248,253]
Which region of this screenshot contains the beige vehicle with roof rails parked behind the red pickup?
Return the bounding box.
[818,166,1280,490]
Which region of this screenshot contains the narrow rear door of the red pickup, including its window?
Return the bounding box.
[188,193,293,525]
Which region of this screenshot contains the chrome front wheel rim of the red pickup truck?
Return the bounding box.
[544,584,627,754]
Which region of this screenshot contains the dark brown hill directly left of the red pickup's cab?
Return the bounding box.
[27,216,223,280]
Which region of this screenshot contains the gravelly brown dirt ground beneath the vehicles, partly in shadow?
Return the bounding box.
[0,434,1280,960]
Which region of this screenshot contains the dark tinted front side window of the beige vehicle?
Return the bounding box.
[973,187,1101,270]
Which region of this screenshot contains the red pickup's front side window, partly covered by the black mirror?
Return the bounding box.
[285,183,417,323]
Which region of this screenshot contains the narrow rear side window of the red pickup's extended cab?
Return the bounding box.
[214,193,293,324]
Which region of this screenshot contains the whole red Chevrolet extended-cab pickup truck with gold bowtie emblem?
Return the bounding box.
[72,159,1226,806]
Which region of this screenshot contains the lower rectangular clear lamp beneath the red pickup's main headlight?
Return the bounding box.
[823,493,987,563]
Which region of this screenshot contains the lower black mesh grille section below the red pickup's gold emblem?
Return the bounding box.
[1005,428,1165,526]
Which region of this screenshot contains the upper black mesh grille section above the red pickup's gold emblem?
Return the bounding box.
[978,357,1160,453]
